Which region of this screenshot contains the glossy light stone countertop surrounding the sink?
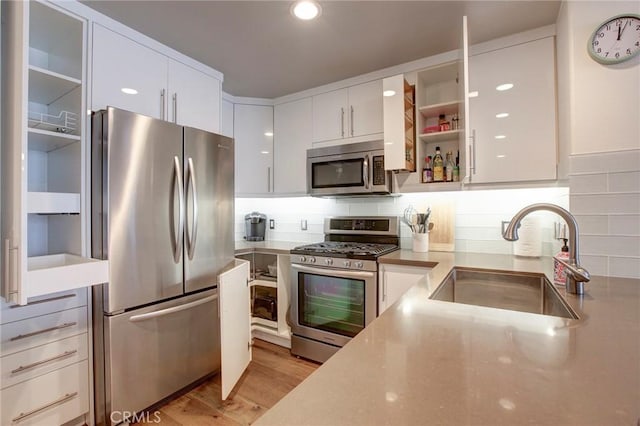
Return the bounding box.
[255,250,640,426]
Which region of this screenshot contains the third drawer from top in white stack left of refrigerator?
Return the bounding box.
[0,334,87,389]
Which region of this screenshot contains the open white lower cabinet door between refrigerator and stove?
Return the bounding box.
[218,260,251,400]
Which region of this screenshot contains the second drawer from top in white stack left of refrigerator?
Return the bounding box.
[0,306,87,356]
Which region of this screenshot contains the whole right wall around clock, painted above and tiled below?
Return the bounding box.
[556,1,640,278]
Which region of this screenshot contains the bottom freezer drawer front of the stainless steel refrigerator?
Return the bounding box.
[104,290,220,419]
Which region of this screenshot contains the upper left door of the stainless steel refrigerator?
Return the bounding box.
[98,108,184,312]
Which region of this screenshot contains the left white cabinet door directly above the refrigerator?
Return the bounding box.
[91,24,168,119]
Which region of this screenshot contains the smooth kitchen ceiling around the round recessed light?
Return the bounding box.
[82,0,560,98]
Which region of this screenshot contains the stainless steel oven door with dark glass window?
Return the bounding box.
[290,263,377,347]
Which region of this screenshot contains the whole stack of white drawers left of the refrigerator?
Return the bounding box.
[0,289,90,425]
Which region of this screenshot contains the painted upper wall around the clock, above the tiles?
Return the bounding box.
[556,1,640,154]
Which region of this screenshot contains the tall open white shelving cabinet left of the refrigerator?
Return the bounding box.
[3,1,108,304]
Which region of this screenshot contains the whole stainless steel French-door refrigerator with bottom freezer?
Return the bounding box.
[91,107,234,424]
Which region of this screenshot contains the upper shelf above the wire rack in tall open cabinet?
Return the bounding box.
[29,65,82,105]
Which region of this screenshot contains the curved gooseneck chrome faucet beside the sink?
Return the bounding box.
[502,203,591,294]
